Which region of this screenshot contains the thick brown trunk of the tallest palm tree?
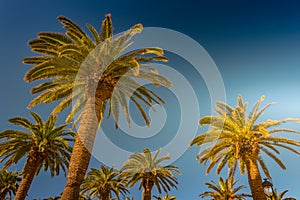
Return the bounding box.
[61,94,102,200]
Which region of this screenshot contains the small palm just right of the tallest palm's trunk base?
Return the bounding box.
[81,165,129,200]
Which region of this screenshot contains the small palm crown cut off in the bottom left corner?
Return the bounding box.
[0,170,21,199]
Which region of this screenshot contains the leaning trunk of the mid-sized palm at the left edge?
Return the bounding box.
[15,150,43,200]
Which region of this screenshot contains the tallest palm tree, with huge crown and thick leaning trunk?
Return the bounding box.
[23,14,171,200]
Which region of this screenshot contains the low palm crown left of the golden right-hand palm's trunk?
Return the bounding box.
[199,176,251,200]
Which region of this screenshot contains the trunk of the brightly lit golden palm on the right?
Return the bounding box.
[245,156,267,200]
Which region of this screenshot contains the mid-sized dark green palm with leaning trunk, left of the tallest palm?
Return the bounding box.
[0,112,75,200]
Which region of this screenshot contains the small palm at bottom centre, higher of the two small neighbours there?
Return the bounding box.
[121,149,181,200]
